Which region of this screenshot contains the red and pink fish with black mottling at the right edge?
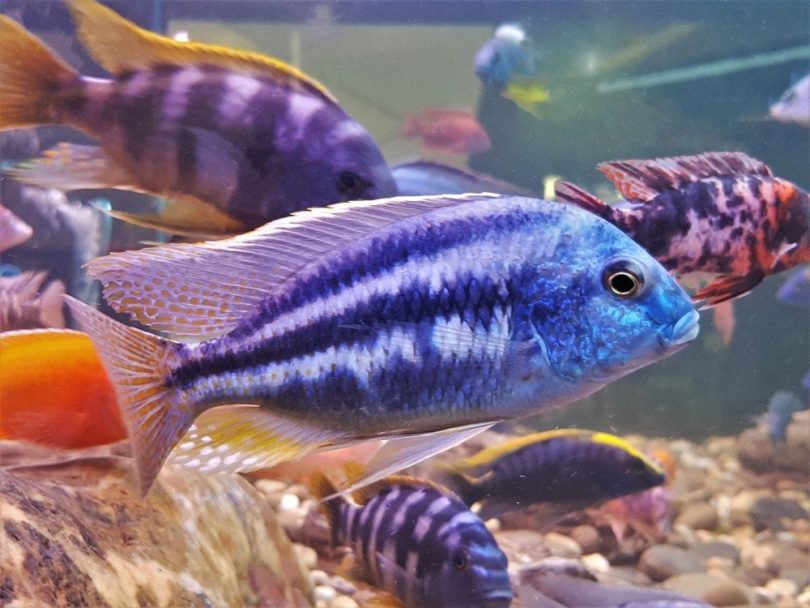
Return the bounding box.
[556,152,810,306]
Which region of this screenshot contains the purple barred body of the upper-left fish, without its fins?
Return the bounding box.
[60,64,395,227]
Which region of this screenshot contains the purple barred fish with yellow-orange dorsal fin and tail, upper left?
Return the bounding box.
[0,0,395,236]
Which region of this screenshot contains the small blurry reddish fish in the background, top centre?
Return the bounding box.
[402,108,492,154]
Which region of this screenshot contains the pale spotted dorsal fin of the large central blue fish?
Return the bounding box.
[89,194,498,340]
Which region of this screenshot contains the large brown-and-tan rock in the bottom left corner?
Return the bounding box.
[0,458,312,608]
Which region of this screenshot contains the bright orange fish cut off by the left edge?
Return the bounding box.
[0,329,127,449]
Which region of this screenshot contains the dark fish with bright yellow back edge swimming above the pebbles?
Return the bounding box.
[438,429,665,519]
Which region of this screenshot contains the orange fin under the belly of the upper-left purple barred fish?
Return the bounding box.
[104,199,247,239]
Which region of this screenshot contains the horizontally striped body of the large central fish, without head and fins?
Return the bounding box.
[167,199,567,432]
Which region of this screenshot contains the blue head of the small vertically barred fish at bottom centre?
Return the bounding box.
[419,499,512,608]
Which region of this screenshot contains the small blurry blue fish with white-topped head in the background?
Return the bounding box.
[474,23,538,89]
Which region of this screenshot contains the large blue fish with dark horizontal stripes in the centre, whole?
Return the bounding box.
[69,194,698,492]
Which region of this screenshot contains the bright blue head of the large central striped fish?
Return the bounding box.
[525,204,698,390]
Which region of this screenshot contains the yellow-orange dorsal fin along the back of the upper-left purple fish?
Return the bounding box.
[68,0,336,103]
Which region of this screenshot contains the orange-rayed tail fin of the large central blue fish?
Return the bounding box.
[65,296,191,496]
